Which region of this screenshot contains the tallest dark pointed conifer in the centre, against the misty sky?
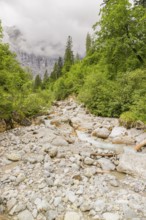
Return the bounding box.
[63,36,74,72]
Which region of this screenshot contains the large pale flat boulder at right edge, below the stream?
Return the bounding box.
[117,150,146,179]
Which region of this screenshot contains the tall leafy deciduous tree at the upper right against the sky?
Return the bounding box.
[94,0,146,76]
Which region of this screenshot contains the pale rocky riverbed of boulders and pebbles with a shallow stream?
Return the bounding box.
[0,99,146,220]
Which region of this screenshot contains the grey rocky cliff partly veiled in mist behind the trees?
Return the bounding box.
[4,26,56,77]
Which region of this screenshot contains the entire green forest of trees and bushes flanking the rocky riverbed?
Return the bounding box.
[0,0,146,127]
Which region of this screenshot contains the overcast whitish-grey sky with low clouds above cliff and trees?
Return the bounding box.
[0,0,102,55]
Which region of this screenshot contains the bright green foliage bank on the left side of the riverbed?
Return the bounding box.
[0,21,52,120]
